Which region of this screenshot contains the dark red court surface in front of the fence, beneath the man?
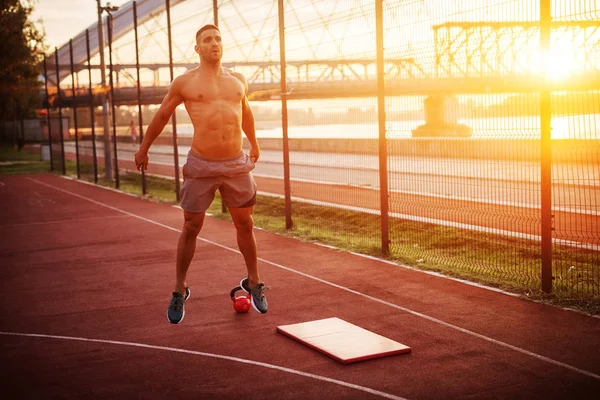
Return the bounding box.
[0,175,600,399]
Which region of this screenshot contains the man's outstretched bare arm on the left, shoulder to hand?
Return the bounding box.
[135,79,183,169]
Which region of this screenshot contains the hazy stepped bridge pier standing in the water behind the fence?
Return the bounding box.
[412,95,473,137]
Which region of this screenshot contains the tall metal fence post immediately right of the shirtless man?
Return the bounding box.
[277,0,294,229]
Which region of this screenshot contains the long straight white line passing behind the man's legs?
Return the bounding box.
[27,178,600,380]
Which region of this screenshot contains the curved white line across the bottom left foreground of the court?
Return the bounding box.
[0,332,406,400]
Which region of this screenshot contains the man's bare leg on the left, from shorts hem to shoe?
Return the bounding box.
[175,211,206,296]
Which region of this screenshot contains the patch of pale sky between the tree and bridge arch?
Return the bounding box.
[32,0,129,49]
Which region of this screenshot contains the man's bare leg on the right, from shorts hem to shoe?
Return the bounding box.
[229,206,260,286]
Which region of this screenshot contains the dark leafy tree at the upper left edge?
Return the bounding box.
[0,0,44,121]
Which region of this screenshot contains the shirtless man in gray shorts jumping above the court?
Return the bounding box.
[135,25,268,324]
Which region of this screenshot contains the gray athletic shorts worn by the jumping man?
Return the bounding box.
[180,151,257,213]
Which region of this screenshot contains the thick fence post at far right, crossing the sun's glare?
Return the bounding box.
[540,0,553,293]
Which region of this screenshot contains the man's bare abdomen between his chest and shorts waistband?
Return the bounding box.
[185,100,242,159]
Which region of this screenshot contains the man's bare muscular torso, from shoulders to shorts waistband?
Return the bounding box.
[178,68,245,159]
